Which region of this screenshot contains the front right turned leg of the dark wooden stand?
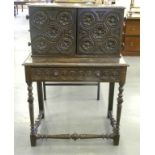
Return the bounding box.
[114,82,124,145]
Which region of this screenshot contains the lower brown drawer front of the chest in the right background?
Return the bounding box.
[125,37,140,52]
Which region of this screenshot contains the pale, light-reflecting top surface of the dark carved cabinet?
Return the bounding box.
[28,3,125,9]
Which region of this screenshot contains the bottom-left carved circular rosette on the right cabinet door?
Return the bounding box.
[80,38,94,53]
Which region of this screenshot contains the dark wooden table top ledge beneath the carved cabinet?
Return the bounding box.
[23,54,128,67]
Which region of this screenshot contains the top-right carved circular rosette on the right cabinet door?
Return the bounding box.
[106,13,120,27]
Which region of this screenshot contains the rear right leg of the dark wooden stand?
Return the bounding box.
[107,82,115,118]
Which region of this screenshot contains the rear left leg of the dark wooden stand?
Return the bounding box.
[37,82,44,118]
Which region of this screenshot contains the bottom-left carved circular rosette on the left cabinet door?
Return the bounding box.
[33,36,49,53]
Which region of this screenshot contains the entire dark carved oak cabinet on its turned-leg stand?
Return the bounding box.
[24,4,128,146]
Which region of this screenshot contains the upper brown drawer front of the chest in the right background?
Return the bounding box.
[126,20,140,35]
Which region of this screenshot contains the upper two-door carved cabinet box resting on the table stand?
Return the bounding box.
[29,4,124,57]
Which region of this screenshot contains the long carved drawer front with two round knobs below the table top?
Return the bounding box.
[31,67,123,82]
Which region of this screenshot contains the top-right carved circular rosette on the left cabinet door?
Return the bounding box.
[57,12,72,26]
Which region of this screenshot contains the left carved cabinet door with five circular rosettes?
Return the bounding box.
[29,7,76,55]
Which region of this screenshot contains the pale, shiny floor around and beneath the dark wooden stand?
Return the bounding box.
[14,9,140,155]
